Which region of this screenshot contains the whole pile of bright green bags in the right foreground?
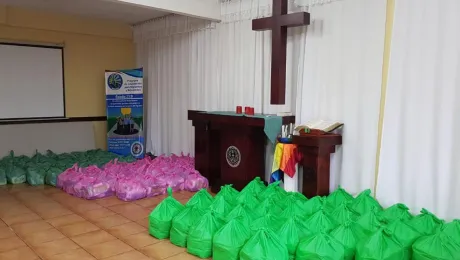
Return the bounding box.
[149,178,460,260]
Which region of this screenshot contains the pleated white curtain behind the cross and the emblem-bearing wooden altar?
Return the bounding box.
[135,0,306,154]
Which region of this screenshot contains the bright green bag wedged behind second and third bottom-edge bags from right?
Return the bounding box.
[330,220,367,260]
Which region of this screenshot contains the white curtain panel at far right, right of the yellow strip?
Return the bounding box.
[377,0,460,219]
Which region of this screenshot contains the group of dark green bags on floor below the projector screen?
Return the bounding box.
[0,150,135,186]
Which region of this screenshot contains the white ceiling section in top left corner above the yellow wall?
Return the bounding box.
[0,0,169,24]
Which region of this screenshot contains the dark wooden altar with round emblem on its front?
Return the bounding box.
[188,110,295,192]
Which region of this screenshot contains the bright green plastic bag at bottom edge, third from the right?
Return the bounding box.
[296,233,346,260]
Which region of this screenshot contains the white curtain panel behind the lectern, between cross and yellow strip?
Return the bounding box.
[296,0,386,193]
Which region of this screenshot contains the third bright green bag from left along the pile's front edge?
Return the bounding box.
[187,210,225,258]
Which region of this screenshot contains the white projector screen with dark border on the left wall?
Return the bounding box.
[0,43,65,120]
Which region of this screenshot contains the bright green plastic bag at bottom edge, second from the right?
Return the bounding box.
[356,228,411,260]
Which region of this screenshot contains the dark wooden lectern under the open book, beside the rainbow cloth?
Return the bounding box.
[292,134,342,198]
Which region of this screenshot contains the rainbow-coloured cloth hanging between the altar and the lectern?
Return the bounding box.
[270,143,302,182]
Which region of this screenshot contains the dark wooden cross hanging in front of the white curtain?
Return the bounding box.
[252,0,310,105]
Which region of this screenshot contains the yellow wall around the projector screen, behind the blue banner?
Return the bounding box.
[0,5,135,148]
